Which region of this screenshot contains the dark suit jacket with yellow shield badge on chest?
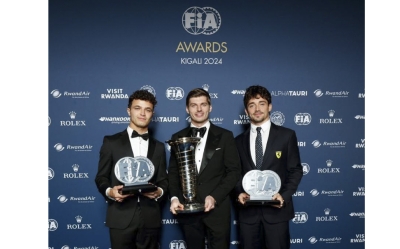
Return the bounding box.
[235,123,303,224]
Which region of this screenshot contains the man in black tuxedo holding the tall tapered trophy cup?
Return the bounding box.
[168,88,240,249]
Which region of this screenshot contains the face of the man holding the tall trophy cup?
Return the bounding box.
[186,96,212,127]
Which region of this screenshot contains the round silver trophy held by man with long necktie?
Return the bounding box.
[242,170,281,205]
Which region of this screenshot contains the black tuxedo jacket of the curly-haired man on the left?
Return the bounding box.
[95,130,168,229]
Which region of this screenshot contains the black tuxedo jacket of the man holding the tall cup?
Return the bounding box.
[168,122,240,225]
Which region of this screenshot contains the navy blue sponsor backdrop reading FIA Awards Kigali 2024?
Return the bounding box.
[48,0,365,249]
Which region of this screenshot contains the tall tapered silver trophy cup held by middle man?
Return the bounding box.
[166,137,204,213]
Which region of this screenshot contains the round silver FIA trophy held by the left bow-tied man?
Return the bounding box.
[114,156,157,195]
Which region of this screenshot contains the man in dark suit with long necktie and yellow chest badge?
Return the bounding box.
[235,85,303,249]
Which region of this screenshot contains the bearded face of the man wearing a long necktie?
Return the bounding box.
[245,95,272,126]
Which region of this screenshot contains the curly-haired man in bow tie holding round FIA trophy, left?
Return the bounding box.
[95,90,168,249]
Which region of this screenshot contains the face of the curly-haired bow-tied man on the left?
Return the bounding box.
[127,99,154,133]
